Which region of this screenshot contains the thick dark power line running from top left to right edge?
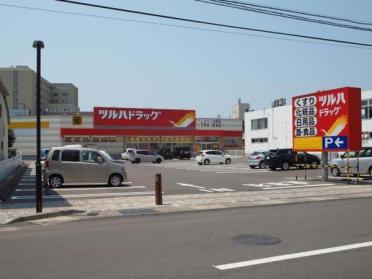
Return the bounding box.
[55,0,372,47]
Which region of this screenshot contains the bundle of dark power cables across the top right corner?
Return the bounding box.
[195,0,372,32]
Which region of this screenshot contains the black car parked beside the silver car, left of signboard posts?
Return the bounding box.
[265,149,320,170]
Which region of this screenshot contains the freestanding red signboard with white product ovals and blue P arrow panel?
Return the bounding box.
[292,87,361,151]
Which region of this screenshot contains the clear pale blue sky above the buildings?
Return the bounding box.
[0,0,372,117]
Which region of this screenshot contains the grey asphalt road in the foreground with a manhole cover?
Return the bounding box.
[0,199,372,279]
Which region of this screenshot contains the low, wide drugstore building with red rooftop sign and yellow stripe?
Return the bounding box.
[11,107,244,156]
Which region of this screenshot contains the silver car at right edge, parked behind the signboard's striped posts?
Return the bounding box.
[329,147,372,176]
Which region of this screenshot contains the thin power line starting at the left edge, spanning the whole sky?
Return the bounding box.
[0,3,370,49]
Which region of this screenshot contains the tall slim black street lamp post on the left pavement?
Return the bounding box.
[32,41,44,213]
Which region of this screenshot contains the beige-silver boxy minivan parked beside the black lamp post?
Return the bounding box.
[43,146,127,188]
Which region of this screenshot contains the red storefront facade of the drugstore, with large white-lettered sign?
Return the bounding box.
[61,107,243,153]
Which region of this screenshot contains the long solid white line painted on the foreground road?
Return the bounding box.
[214,241,372,270]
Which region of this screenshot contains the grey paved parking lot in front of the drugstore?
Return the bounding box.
[8,158,368,206]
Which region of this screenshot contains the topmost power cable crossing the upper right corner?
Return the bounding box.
[203,0,372,26]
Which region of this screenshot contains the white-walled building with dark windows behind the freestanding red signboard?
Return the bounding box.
[245,90,372,154]
